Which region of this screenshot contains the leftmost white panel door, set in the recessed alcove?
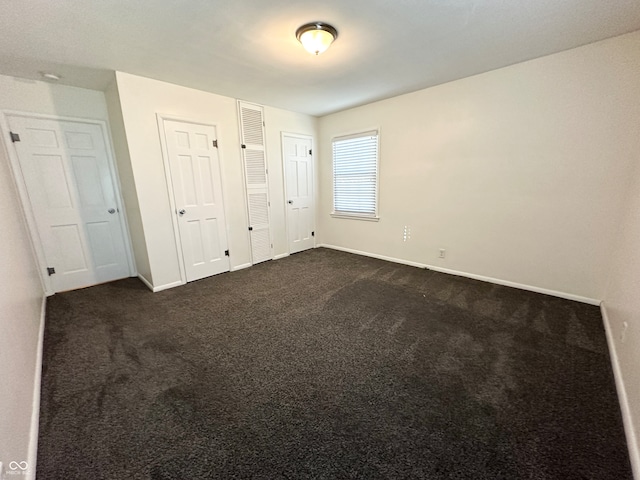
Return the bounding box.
[7,116,129,292]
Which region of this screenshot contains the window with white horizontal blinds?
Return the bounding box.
[332,130,378,220]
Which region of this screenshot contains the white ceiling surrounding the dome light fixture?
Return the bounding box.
[0,0,640,115]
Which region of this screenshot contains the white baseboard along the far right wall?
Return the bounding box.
[600,302,640,480]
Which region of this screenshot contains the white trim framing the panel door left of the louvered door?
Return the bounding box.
[154,113,233,284]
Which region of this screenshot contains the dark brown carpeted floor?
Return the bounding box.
[37,249,632,480]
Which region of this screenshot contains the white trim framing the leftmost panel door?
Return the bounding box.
[0,110,137,296]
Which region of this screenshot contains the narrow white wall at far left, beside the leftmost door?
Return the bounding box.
[0,130,45,480]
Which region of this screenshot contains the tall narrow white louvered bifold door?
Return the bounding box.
[238,102,273,264]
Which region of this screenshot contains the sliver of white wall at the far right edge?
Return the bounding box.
[603,152,640,478]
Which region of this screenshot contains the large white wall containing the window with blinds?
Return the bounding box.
[318,32,640,300]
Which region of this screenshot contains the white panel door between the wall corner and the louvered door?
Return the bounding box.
[164,120,229,282]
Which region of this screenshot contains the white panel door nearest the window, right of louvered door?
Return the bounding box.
[282,134,314,253]
